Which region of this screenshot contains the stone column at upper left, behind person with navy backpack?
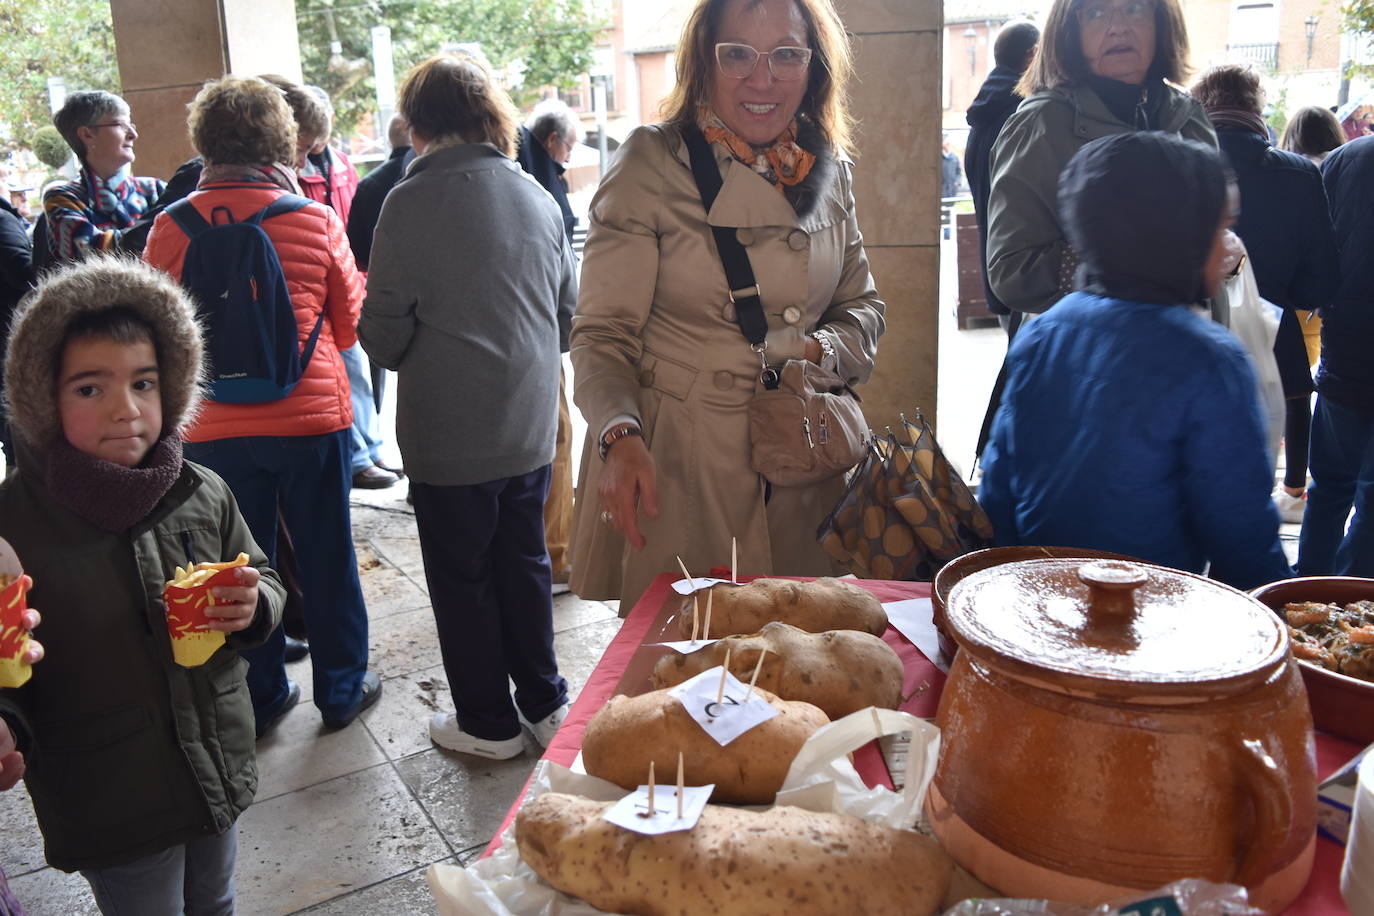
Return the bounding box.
[110,0,301,179]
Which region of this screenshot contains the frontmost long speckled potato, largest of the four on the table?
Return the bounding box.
[515,792,952,916]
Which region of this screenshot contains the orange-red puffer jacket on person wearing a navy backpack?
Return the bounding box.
[143,184,363,442]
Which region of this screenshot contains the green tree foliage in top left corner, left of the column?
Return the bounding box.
[0,0,120,150]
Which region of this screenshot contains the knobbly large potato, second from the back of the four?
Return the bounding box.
[653,621,901,718]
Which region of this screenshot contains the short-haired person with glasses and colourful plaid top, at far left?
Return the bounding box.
[43,89,165,264]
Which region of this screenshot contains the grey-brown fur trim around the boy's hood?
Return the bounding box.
[4,255,205,450]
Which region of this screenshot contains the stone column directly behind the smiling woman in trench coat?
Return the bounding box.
[835,0,943,430]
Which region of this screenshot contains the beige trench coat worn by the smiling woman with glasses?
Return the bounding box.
[572,125,883,614]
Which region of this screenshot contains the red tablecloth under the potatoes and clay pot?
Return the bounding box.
[482,570,1360,916]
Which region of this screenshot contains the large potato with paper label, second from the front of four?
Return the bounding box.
[583,691,830,805]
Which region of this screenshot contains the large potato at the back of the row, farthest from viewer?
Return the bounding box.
[677,578,888,639]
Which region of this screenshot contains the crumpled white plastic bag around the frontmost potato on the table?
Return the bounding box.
[426,709,940,916]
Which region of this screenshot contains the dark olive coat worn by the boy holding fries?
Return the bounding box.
[0,463,286,871]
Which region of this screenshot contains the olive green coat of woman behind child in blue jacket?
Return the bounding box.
[988,84,1216,318]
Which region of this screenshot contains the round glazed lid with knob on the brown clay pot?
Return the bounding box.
[948,559,1287,702]
